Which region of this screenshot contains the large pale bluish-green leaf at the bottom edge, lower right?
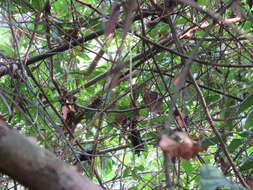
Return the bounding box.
[200,165,244,190]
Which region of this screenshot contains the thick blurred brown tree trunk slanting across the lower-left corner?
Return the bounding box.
[0,120,101,190]
